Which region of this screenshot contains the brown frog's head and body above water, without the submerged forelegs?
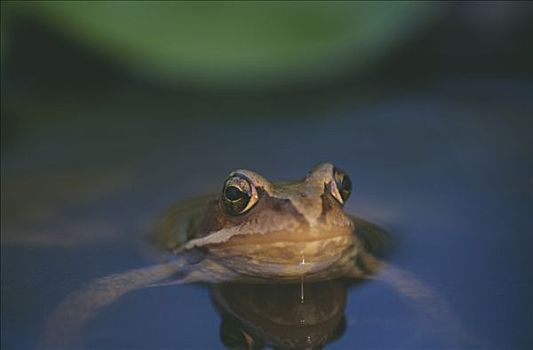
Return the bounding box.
[155,163,383,282]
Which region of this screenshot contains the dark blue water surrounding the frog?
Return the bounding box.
[1,81,533,349]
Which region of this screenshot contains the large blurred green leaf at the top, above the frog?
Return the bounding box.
[12,1,438,86]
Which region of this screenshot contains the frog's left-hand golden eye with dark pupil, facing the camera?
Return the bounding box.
[221,175,258,215]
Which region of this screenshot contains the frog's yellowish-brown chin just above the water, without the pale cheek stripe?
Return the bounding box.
[209,229,354,280]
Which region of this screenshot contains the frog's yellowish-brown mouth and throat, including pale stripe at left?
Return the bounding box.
[180,226,357,278]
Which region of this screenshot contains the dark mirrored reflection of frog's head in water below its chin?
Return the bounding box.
[211,279,346,349]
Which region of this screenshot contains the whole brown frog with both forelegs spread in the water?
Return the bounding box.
[46,163,462,346]
